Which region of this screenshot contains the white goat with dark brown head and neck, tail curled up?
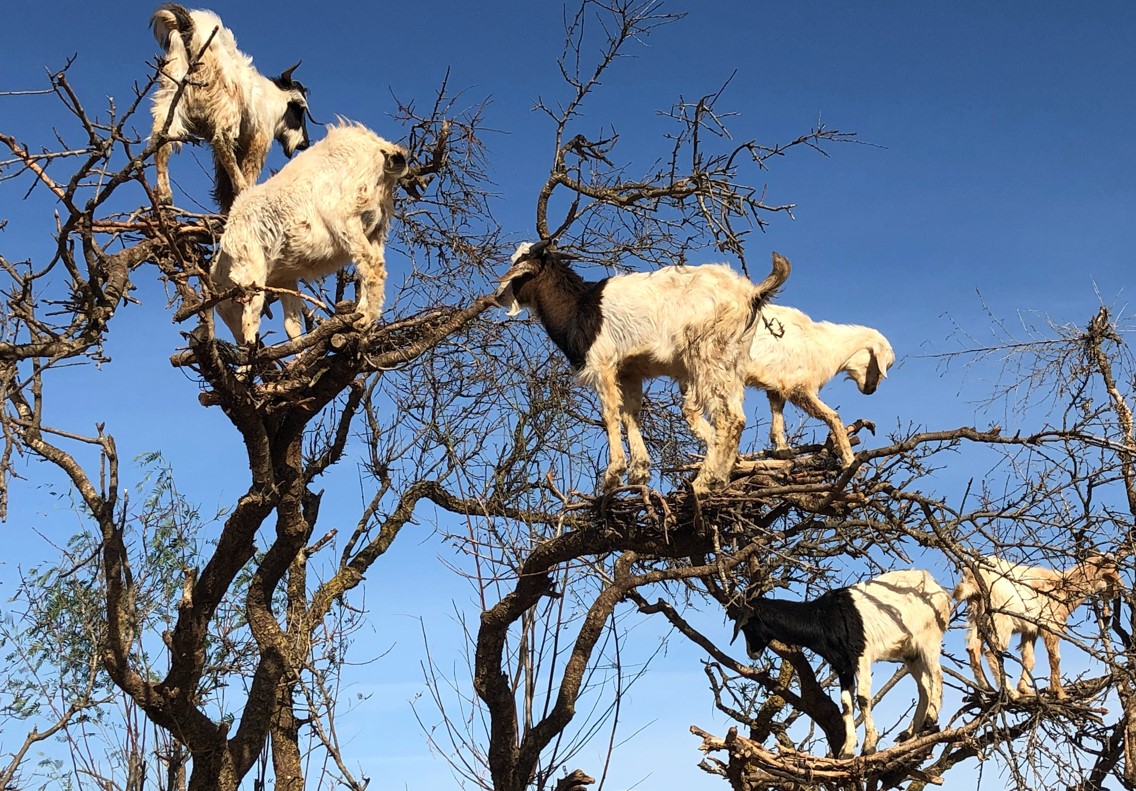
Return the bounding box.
[496,241,790,492]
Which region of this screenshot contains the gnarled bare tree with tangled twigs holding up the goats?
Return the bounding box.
[0,0,1136,791]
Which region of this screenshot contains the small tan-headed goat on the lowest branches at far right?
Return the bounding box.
[954,552,1121,698]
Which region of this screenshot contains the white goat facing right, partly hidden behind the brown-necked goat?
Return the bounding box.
[683,305,895,467]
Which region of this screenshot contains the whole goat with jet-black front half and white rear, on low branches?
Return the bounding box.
[734,571,951,758]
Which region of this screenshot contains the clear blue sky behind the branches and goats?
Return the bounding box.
[0,0,1136,789]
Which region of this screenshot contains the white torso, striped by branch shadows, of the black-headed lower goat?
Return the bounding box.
[849,569,951,661]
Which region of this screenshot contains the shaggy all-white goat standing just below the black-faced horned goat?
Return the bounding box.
[210,122,407,343]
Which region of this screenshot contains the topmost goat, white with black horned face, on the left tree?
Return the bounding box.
[150,3,309,213]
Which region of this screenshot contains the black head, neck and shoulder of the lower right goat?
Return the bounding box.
[742,588,866,689]
